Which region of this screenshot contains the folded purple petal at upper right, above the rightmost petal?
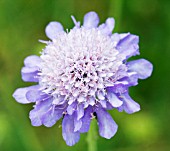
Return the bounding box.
[116,33,139,59]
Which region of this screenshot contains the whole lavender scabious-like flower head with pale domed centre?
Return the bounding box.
[13,12,153,146]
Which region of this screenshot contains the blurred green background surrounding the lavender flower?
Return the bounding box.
[0,0,170,151]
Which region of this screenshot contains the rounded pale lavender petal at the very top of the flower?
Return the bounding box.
[83,12,99,28]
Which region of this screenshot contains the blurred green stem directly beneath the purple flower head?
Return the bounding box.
[87,119,97,151]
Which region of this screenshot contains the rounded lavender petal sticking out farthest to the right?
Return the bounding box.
[127,59,153,79]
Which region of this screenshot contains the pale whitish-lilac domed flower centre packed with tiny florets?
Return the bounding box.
[40,27,126,102]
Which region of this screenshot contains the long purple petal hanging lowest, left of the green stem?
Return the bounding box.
[62,114,80,146]
